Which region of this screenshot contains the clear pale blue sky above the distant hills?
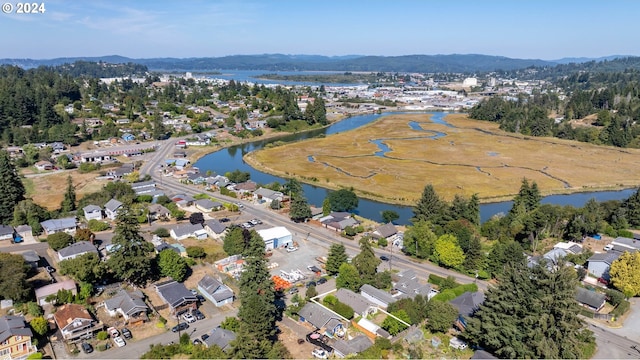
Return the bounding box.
[0,0,640,60]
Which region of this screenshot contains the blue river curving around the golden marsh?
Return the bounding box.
[194,112,635,225]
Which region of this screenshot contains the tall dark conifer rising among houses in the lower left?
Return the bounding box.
[107,203,153,285]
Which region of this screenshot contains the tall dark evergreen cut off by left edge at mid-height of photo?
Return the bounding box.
[0,150,26,225]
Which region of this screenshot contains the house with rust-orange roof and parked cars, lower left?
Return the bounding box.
[53,304,104,342]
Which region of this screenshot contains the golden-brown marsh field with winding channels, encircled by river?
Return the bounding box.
[245,114,640,204]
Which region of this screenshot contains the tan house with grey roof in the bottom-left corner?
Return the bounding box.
[0,315,38,360]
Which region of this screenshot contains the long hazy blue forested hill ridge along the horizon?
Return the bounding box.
[0,54,555,73]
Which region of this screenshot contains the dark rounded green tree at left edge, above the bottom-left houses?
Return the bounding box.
[0,253,31,301]
